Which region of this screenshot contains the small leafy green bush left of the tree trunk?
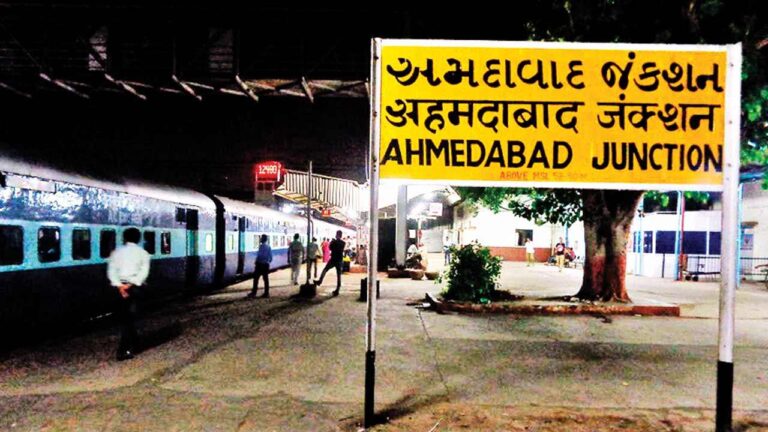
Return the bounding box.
[438,243,501,303]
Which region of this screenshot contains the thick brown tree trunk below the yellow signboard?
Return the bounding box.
[576,190,643,302]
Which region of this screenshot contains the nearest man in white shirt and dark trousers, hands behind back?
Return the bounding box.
[107,228,150,360]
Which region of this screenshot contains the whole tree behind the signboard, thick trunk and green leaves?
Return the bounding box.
[458,0,768,302]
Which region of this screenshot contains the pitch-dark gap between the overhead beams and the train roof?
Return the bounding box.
[0,97,368,199]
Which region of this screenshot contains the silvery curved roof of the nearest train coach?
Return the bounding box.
[0,155,216,209]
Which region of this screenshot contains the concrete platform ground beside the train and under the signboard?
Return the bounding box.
[0,257,768,431]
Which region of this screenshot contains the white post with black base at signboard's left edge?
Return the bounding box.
[363,38,381,427]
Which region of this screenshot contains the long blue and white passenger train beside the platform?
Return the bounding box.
[0,157,355,334]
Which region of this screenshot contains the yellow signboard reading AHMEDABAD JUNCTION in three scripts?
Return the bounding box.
[374,40,727,190]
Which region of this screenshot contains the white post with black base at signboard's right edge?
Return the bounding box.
[715,44,741,432]
